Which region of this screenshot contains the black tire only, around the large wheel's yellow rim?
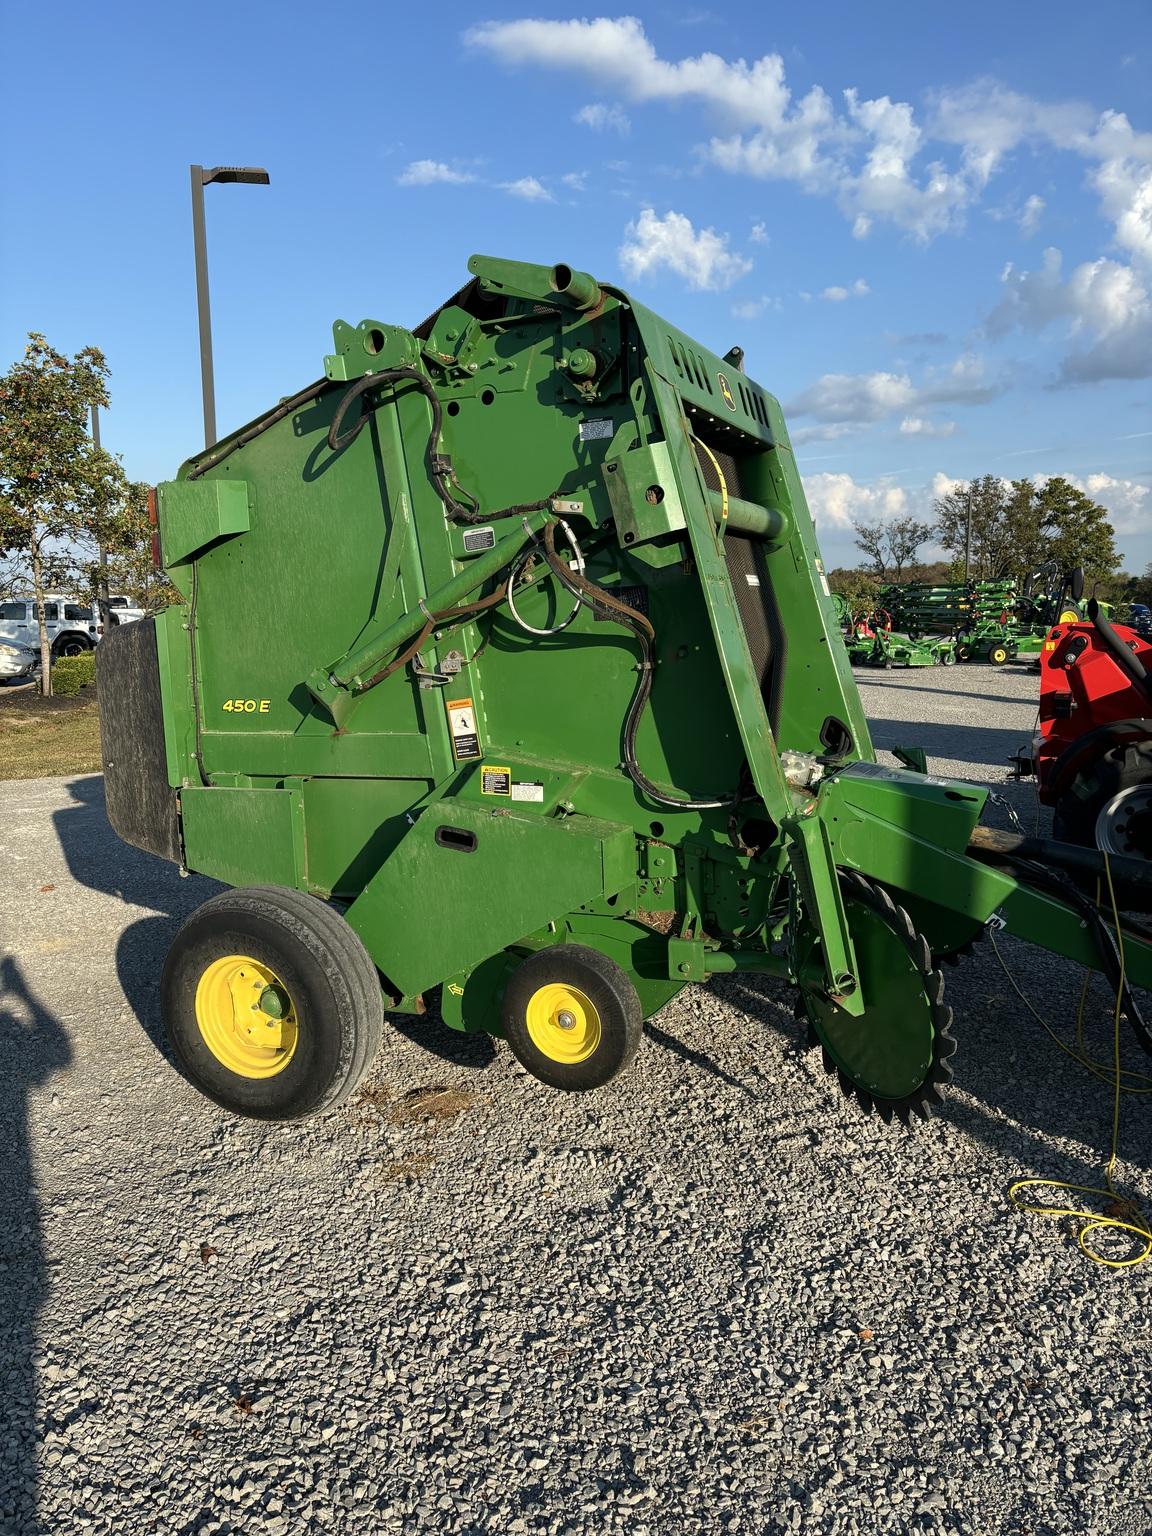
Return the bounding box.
[160,885,384,1120]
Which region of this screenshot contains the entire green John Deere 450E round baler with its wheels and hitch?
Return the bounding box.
[100,257,1152,1120]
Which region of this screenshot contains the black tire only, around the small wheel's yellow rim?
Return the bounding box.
[502,945,644,1094]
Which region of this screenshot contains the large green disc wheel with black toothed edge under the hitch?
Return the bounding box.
[796,869,955,1124]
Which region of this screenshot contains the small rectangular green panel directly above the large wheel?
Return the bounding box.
[180,786,304,886]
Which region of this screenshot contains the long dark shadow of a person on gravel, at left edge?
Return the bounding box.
[0,955,72,1536]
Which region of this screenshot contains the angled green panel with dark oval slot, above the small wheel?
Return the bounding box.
[347,802,636,995]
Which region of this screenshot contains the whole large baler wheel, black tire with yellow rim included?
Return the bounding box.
[160,885,384,1120]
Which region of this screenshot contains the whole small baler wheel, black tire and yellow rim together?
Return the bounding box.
[502,945,644,1092]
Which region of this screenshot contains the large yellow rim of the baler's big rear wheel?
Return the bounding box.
[195,955,300,1078]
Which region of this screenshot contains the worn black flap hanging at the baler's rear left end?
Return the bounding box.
[97,619,181,863]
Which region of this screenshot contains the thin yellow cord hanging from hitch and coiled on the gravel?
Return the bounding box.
[989,852,1152,1269]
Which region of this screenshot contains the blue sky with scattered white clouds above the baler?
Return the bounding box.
[0,0,1152,568]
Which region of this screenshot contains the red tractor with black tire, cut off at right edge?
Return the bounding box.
[1017,599,1152,859]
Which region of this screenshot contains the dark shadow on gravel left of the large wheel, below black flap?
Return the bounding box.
[54,774,223,1061]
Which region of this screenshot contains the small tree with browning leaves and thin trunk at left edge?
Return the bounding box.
[0,332,110,696]
